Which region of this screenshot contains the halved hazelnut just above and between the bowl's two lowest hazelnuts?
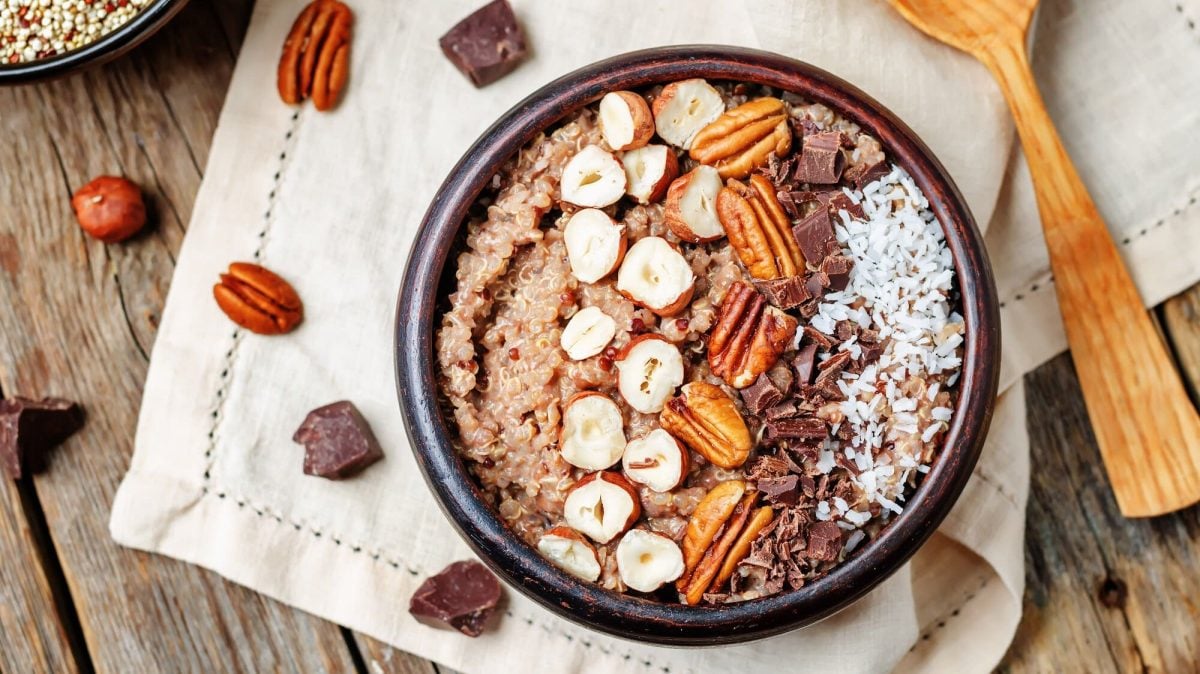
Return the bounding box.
[563,471,642,543]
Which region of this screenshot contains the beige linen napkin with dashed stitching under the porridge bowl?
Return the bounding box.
[112,0,1200,674]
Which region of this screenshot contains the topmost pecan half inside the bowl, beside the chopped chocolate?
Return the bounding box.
[690,97,792,177]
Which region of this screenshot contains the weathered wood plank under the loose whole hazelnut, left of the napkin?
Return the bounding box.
[0,1,354,672]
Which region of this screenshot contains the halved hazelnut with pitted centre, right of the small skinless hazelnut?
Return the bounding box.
[617,333,683,414]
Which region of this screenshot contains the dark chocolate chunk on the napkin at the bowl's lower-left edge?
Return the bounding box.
[408,561,500,637]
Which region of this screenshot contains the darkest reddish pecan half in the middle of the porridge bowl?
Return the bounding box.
[708,282,797,389]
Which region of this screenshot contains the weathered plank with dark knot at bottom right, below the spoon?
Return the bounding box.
[1001,347,1200,672]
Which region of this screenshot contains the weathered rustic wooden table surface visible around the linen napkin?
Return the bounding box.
[0,0,1200,673]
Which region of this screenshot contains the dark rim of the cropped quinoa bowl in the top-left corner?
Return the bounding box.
[0,0,188,85]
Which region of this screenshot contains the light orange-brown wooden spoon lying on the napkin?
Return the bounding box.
[890,0,1200,517]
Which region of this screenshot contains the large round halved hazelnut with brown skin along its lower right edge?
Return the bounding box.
[617,236,696,315]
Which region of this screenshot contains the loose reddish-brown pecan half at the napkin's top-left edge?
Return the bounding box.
[277,0,354,110]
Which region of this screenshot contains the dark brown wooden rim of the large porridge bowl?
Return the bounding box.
[395,46,1000,645]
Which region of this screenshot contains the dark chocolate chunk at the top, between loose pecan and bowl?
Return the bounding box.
[438,0,526,86]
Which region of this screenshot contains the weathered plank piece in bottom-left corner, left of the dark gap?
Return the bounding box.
[0,475,79,673]
